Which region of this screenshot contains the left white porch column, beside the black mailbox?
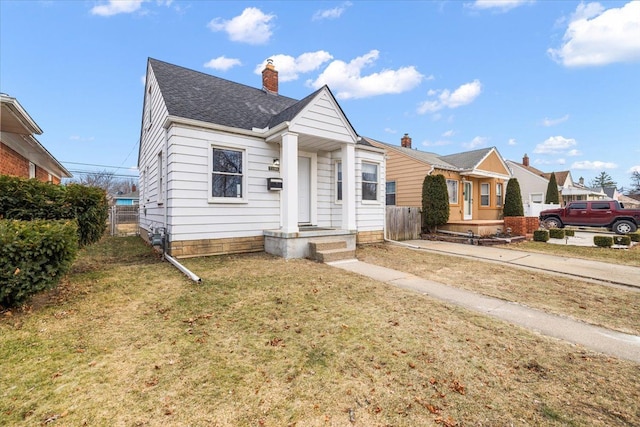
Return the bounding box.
[280,132,300,233]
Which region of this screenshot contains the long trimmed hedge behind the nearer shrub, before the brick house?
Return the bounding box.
[0,176,109,246]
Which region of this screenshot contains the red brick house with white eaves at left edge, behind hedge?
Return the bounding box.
[0,94,72,184]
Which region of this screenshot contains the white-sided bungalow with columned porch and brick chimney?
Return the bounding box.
[138,58,385,258]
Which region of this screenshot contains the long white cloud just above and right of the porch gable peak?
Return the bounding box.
[307,50,424,99]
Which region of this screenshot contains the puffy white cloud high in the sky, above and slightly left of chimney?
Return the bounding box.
[207,7,276,44]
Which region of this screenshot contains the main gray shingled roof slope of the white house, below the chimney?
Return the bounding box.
[149,58,302,130]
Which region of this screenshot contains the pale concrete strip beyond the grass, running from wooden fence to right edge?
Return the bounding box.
[398,240,640,289]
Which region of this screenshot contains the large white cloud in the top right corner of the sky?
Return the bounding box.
[547,1,640,67]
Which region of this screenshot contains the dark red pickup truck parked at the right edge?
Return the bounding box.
[540,200,640,234]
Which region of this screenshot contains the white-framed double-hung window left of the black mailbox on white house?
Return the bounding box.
[211,147,245,199]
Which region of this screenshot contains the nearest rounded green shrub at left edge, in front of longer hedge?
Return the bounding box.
[0,220,78,307]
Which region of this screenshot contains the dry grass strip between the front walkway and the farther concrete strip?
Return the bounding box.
[357,245,640,335]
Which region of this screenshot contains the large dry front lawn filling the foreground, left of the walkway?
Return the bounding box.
[0,238,640,426]
